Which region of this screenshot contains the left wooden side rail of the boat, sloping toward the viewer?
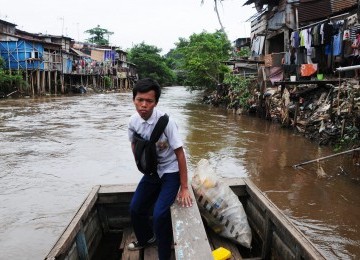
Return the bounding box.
[45,185,100,259]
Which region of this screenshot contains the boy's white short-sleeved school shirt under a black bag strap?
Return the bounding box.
[128,109,183,178]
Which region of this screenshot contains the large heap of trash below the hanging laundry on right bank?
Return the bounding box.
[267,81,360,145]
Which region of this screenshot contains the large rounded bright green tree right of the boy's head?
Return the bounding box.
[175,31,231,90]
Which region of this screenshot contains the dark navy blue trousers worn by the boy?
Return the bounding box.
[130,172,180,260]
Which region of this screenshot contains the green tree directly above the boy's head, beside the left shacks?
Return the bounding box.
[128,42,175,86]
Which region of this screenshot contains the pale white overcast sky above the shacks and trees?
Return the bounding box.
[0,0,256,53]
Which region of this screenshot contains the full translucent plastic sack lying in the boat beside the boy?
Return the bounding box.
[192,159,252,248]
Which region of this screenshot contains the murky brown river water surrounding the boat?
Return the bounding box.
[0,87,360,260]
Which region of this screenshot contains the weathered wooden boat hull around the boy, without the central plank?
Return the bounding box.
[45,178,325,259]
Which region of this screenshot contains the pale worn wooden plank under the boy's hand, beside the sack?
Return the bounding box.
[171,189,212,260]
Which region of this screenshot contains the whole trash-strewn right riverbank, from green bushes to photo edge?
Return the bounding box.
[204,79,360,150]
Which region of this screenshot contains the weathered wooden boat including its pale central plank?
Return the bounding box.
[45,178,325,260]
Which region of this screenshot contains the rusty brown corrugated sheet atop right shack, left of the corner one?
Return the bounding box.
[298,0,332,23]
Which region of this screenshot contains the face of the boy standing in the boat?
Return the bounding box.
[133,90,157,120]
